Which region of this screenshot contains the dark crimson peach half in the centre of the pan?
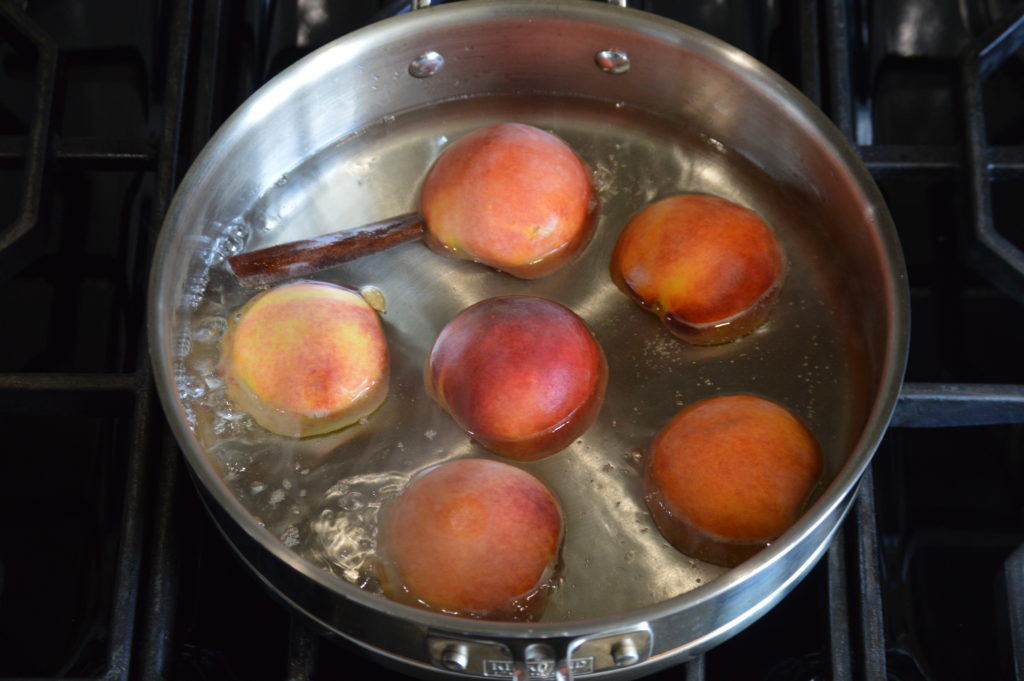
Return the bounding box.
[426,296,608,461]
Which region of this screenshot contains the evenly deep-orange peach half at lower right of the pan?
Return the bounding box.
[645,394,821,566]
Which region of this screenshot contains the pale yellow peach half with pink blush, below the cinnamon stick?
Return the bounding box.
[220,282,389,437]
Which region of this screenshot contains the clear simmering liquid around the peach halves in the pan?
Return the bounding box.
[177,96,859,621]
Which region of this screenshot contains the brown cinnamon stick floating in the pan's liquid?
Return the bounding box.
[227,213,425,287]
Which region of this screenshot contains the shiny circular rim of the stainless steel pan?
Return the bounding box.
[147,0,909,639]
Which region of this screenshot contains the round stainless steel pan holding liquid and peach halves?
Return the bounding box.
[150,0,908,678]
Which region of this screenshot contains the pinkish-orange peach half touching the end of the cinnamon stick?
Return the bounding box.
[420,123,597,279]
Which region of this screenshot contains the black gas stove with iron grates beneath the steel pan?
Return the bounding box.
[0,0,1024,681]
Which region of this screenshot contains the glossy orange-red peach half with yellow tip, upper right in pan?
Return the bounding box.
[611,194,785,345]
